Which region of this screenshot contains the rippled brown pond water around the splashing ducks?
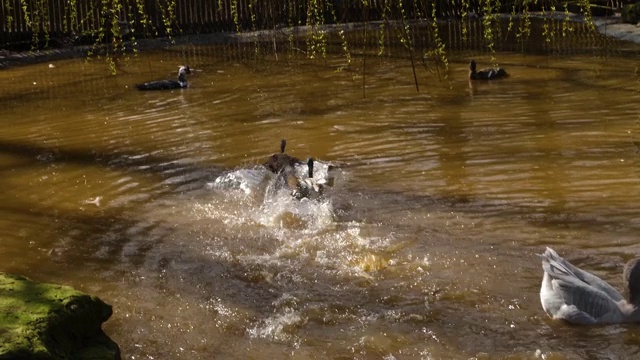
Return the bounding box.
[0,21,640,359]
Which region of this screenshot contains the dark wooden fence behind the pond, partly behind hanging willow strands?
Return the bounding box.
[0,0,490,46]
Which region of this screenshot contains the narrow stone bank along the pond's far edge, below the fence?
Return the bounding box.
[0,12,640,69]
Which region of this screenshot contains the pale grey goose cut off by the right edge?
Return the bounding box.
[540,248,640,324]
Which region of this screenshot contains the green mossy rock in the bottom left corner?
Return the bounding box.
[0,273,120,360]
